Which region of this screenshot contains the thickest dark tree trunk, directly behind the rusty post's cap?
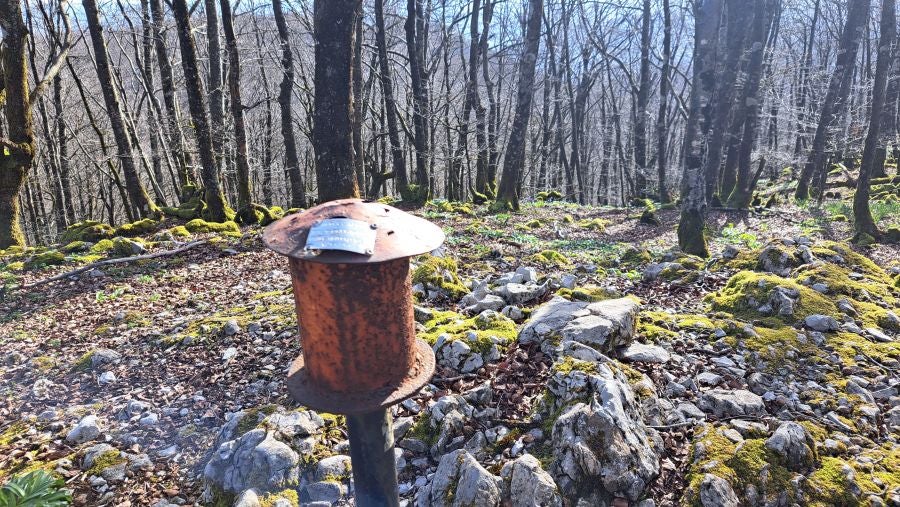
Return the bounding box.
[312,0,362,202]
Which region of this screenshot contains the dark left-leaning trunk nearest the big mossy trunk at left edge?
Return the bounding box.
[82,0,159,217]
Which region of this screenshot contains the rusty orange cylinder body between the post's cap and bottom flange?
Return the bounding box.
[290,257,417,393]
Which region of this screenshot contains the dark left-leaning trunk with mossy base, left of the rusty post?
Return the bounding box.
[172,0,229,222]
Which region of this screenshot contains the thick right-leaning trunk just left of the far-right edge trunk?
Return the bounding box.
[794,0,869,199]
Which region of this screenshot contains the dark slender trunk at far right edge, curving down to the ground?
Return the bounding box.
[853,0,897,240]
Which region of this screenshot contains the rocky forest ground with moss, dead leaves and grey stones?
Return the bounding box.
[0,196,900,507]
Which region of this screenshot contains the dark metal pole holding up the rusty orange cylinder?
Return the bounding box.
[347,409,400,507]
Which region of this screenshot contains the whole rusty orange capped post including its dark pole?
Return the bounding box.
[263,199,444,507]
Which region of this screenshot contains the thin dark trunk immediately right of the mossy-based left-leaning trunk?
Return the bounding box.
[219,0,257,224]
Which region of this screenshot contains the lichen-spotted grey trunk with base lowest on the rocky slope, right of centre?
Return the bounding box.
[678,0,723,257]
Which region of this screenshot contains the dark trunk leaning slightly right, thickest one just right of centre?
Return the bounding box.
[496,0,544,211]
